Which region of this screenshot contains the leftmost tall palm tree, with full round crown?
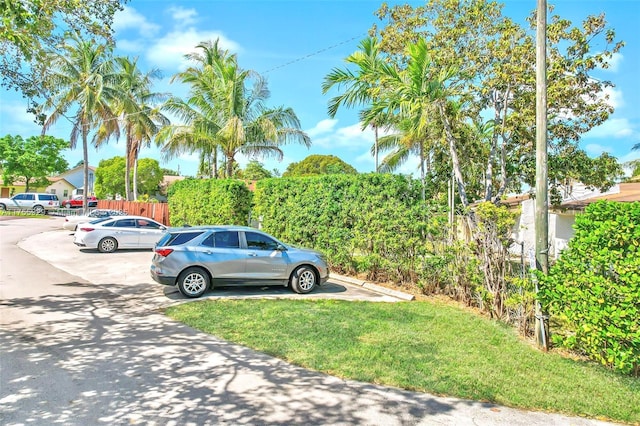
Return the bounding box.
[42,34,123,209]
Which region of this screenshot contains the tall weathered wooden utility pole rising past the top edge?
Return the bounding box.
[535,0,549,351]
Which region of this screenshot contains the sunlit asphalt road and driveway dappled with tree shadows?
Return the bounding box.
[0,218,616,425]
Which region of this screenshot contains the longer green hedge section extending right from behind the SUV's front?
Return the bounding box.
[253,174,446,282]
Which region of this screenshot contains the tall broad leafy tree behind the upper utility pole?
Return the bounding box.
[378,0,623,201]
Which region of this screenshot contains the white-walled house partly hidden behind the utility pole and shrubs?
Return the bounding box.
[502,182,640,258]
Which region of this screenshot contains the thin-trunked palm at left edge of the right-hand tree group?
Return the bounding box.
[322,37,391,172]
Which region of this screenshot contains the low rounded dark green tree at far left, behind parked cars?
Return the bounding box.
[0,135,69,192]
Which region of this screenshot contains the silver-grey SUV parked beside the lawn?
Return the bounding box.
[150,226,329,297]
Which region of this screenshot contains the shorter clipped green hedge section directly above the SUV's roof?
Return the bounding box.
[168,179,252,226]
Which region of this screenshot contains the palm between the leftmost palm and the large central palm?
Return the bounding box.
[110,58,169,200]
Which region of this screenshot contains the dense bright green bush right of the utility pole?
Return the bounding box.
[540,201,640,375]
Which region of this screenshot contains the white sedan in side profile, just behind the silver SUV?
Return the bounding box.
[73,215,167,253]
